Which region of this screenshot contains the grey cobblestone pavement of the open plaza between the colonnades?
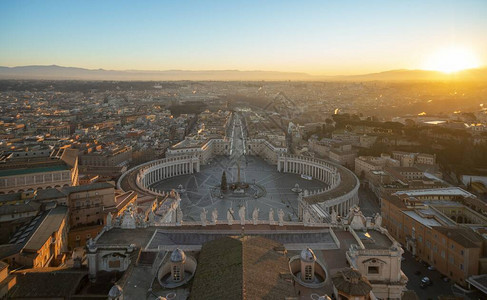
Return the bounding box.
[153,156,326,221]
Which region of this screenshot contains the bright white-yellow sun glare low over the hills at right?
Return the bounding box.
[425,47,480,73]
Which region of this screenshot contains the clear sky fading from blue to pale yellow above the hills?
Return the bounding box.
[0,0,487,75]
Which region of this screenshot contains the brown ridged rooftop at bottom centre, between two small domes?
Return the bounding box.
[191,237,295,299]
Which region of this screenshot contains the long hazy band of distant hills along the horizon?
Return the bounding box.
[0,65,487,81]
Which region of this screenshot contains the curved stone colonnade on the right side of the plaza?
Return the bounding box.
[277,155,360,222]
